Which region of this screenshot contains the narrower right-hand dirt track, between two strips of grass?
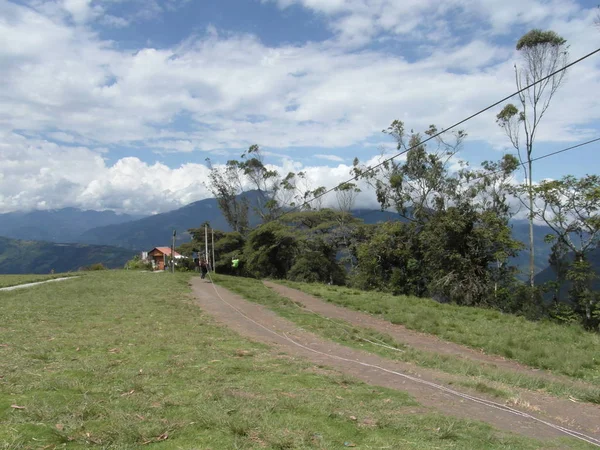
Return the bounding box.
[264,281,600,388]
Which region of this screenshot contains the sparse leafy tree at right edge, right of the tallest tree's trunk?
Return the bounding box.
[534,175,600,327]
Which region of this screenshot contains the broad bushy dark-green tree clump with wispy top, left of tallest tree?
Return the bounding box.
[353,121,520,305]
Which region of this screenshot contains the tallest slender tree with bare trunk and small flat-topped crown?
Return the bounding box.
[496,29,568,288]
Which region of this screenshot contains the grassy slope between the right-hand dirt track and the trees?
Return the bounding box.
[282,282,600,386]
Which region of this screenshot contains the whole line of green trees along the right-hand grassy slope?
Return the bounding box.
[181,30,600,330]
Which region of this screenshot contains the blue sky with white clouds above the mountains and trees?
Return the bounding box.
[0,0,600,214]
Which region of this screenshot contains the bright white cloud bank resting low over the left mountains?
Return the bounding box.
[0,133,209,214]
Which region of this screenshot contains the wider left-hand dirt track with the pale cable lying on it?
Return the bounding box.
[192,278,600,439]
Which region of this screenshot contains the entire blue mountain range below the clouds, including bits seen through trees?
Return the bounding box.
[0,199,550,279]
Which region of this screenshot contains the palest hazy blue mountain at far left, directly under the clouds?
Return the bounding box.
[0,208,142,242]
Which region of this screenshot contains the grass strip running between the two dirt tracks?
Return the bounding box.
[213,275,600,403]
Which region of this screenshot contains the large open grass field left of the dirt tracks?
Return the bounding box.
[0,271,589,449]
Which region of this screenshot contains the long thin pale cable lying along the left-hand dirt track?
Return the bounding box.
[203,272,600,447]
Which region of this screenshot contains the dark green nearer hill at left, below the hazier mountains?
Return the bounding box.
[0,237,135,274]
